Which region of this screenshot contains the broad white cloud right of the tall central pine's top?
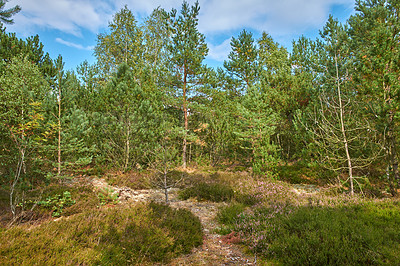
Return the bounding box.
[199,0,354,35]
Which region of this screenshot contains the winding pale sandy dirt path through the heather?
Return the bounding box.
[92,179,255,265]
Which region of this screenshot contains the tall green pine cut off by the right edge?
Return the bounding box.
[349,0,400,193]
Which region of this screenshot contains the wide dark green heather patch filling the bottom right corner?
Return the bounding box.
[228,202,400,265]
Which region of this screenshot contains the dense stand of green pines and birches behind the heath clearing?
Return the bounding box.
[0,0,400,265]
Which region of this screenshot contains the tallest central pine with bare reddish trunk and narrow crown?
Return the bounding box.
[168,1,208,168]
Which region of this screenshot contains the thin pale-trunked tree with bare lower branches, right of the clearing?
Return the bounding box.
[296,16,379,195]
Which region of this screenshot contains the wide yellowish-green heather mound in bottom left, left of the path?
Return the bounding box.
[0,203,202,265]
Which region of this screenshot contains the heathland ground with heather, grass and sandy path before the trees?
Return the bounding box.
[0,167,400,265]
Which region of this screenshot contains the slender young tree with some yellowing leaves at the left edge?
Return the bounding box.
[0,56,50,216]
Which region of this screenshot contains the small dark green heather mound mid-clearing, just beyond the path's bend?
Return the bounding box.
[179,183,234,202]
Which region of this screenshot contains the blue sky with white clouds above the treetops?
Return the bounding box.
[6,0,355,69]
